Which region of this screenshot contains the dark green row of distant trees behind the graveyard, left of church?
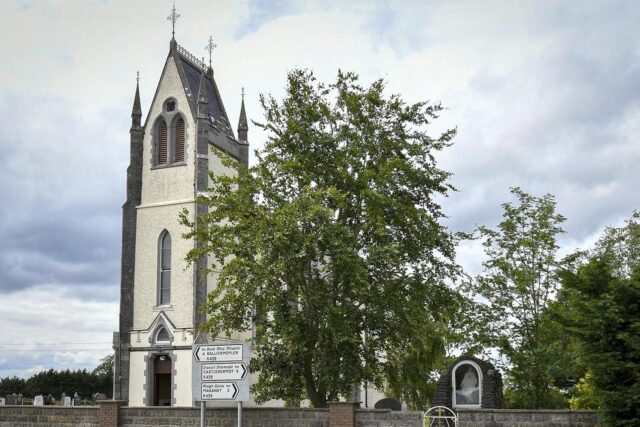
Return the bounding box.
[0,356,113,400]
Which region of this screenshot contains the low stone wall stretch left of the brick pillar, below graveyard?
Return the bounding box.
[0,406,101,427]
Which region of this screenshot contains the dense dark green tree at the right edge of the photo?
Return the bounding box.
[557,212,640,426]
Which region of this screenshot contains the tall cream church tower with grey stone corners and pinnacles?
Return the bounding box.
[113,34,249,406]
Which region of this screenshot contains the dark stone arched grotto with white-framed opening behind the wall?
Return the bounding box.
[433,356,504,410]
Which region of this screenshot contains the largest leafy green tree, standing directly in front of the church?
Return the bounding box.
[181,70,458,407]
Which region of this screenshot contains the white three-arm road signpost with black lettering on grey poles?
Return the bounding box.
[192,343,250,427]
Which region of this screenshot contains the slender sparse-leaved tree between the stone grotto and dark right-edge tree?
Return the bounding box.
[469,188,565,408]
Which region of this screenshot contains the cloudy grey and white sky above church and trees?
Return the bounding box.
[0,0,640,377]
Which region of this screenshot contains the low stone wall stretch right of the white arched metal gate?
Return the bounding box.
[458,409,599,427]
